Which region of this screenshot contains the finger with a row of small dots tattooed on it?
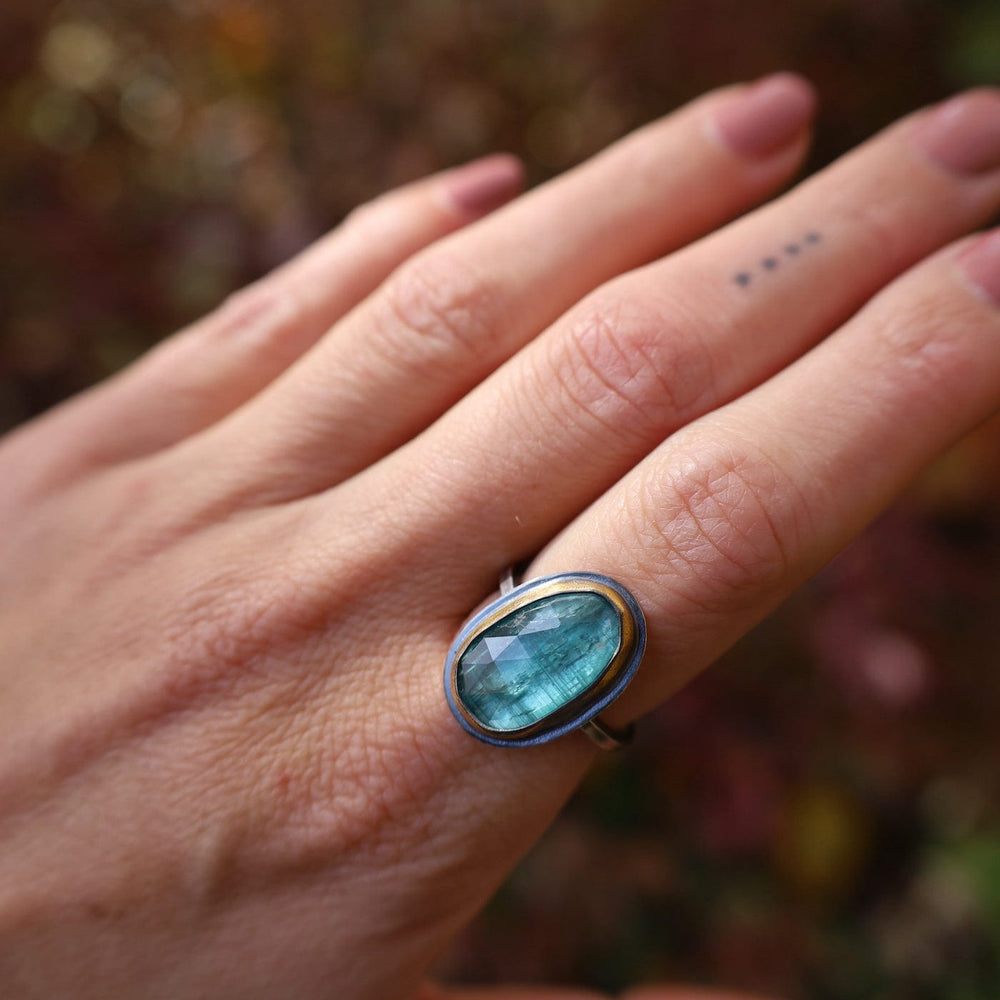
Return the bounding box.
[362,93,1000,595]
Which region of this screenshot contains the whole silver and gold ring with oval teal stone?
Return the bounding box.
[444,569,646,750]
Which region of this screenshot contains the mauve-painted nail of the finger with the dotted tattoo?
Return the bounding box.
[913,90,1000,174]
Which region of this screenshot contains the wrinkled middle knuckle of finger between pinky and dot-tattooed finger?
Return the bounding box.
[377,248,503,366]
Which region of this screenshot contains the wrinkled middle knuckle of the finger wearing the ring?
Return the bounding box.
[636,441,808,613]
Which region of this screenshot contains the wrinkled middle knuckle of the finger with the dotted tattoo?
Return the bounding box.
[557,293,714,438]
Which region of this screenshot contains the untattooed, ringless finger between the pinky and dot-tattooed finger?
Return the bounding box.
[191,75,813,497]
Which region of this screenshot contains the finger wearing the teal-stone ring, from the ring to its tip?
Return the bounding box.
[532,230,1000,718]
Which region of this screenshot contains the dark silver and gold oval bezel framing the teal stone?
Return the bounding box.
[444,573,646,746]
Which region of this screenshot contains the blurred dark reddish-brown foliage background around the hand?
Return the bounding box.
[0,0,1000,1000]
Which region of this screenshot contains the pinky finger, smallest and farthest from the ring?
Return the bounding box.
[1,155,523,496]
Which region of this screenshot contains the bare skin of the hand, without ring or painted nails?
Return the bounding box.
[0,78,1000,1000]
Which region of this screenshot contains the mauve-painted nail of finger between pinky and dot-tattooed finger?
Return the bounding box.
[715,73,816,159]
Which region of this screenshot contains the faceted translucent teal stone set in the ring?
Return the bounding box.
[456,592,621,732]
